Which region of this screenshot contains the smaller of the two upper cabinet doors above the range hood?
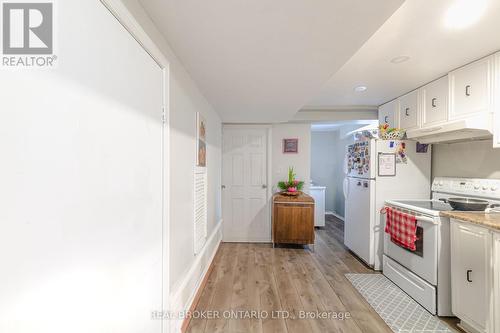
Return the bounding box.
[421,76,449,127]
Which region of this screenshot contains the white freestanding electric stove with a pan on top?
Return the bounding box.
[382,177,500,316]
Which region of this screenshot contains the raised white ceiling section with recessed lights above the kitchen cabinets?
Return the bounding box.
[307,0,500,109]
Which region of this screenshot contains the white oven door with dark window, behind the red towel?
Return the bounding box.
[383,207,439,285]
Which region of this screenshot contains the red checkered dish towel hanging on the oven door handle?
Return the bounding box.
[385,207,417,251]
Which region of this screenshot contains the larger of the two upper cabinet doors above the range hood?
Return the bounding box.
[449,56,494,120]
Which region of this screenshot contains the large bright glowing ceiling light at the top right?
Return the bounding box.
[444,0,488,30]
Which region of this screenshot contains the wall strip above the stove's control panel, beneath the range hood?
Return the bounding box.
[432,141,500,179]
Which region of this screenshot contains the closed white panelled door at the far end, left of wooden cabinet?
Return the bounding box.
[222,126,271,242]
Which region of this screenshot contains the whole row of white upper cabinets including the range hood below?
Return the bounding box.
[379,52,500,147]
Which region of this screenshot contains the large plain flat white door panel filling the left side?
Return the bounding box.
[0,0,163,333]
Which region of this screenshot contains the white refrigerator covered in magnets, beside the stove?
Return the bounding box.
[344,139,431,270]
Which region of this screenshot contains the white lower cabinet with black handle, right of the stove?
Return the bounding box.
[451,220,500,333]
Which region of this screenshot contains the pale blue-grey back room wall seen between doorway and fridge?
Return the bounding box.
[311,131,338,212]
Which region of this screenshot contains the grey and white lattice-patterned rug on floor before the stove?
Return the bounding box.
[345,274,451,333]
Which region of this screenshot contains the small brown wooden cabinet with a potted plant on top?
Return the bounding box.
[272,193,314,245]
